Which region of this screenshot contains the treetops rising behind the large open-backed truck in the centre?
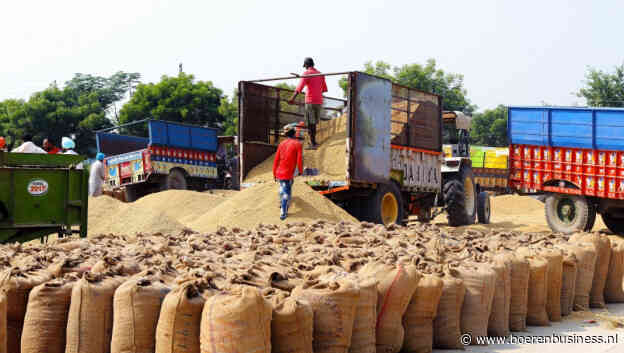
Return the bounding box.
[340,59,476,114]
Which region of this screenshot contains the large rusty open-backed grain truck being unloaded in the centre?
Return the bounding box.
[238,72,489,225]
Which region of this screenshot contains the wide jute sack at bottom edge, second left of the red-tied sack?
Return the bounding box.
[291,280,360,353]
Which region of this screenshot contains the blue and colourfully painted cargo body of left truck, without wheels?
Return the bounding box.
[97,120,218,192]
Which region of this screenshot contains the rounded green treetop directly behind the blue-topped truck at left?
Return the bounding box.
[119,72,225,136]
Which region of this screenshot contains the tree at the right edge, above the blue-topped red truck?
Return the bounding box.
[577,64,624,107]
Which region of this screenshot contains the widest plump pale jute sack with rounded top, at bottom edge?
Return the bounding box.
[200,286,272,353]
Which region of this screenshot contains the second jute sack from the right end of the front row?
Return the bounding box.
[570,233,611,308]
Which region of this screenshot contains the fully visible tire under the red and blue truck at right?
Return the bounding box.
[544,194,591,234]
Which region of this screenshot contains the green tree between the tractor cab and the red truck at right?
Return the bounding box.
[470,105,507,147]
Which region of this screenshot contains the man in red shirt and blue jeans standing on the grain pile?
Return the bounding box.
[273,125,303,220]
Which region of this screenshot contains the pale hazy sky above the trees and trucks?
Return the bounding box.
[0,0,624,110]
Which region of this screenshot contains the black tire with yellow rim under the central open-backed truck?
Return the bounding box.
[365,183,405,225]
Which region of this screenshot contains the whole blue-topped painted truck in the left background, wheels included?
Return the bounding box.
[96,119,223,202]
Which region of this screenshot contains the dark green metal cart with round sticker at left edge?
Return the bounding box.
[0,151,89,243]
